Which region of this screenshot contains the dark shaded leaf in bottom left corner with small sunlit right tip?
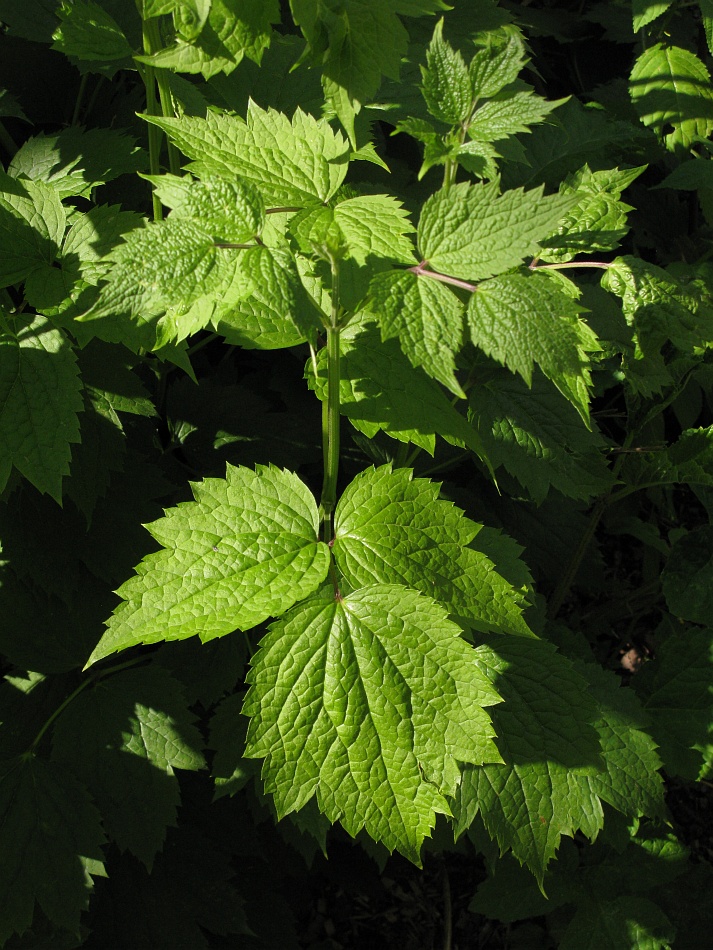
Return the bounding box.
[0,755,104,943]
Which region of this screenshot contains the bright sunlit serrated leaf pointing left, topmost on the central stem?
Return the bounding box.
[145,102,349,206]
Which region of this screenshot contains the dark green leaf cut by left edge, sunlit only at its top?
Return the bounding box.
[0,311,82,503]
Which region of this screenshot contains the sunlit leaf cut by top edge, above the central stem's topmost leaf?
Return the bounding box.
[136,0,280,79]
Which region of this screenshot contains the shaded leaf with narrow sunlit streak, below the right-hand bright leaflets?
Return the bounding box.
[469,372,613,504]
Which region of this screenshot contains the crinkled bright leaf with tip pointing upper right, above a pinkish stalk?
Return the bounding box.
[540,165,646,262]
